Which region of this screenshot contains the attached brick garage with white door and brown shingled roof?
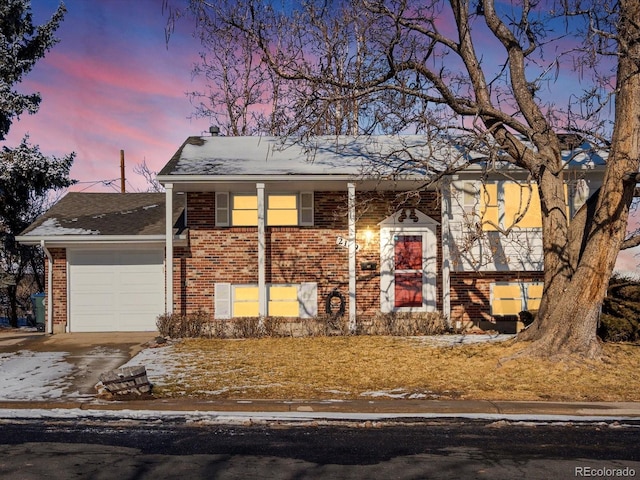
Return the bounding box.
[17,192,186,333]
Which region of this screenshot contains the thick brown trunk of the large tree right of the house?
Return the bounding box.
[520,0,640,358]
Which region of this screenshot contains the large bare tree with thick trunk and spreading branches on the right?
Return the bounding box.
[166,0,640,358]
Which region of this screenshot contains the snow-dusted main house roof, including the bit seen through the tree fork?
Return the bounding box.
[158,135,608,183]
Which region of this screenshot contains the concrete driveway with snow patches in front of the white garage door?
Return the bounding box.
[0,330,158,401]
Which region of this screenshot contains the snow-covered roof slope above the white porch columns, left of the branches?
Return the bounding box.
[158,135,465,181]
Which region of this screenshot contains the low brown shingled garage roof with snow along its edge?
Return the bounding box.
[18,192,183,243]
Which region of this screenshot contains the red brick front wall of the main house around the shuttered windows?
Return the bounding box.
[174,191,442,317]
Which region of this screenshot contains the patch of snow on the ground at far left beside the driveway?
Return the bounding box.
[0,350,73,401]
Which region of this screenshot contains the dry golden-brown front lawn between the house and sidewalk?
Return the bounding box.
[155,336,640,401]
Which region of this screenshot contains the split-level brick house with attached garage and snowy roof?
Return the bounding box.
[19,136,606,332]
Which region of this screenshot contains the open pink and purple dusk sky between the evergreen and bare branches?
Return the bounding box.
[4,0,638,274]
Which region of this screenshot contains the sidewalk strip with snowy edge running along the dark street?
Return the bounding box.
[0,398,640,421]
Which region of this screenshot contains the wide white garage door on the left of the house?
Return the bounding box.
[68,250,164,332]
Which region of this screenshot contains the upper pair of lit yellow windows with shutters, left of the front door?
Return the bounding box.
[216,192,313,227]
